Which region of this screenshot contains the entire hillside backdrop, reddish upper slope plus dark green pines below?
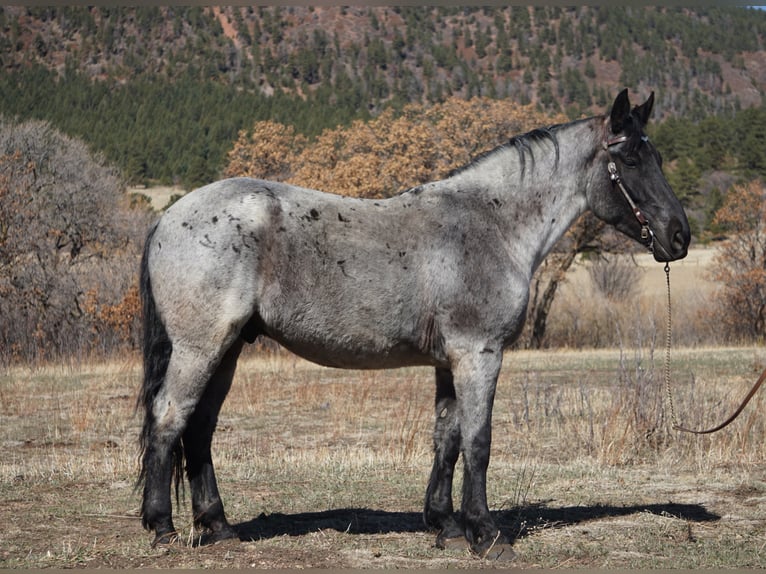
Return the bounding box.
[0,6,766,190]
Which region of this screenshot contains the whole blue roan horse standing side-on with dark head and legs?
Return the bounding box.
[141,90,690,555]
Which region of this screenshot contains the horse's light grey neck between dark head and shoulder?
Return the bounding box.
[450,118,601,277]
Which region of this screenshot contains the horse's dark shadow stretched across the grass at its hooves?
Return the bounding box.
[235,502,721,541]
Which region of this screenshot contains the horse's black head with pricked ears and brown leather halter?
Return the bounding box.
[588,90,691,261]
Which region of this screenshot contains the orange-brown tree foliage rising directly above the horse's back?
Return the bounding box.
[225,98,565,198]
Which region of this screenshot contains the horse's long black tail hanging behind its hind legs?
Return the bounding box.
[136,223,183,497]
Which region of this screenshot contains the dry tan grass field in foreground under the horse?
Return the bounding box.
[0,347,766,568]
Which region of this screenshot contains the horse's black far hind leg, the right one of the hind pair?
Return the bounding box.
[183,339,242,542]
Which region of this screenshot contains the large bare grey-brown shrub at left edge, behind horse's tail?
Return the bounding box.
[0,119,149,363]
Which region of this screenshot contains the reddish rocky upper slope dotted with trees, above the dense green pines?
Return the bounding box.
[6,6,766,116]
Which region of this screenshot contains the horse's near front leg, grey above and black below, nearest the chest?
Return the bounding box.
[453,347,514,560]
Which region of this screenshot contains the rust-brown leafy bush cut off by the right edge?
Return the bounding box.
[710,180,766,340]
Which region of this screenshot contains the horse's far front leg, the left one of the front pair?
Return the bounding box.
[423,369,464,548]
